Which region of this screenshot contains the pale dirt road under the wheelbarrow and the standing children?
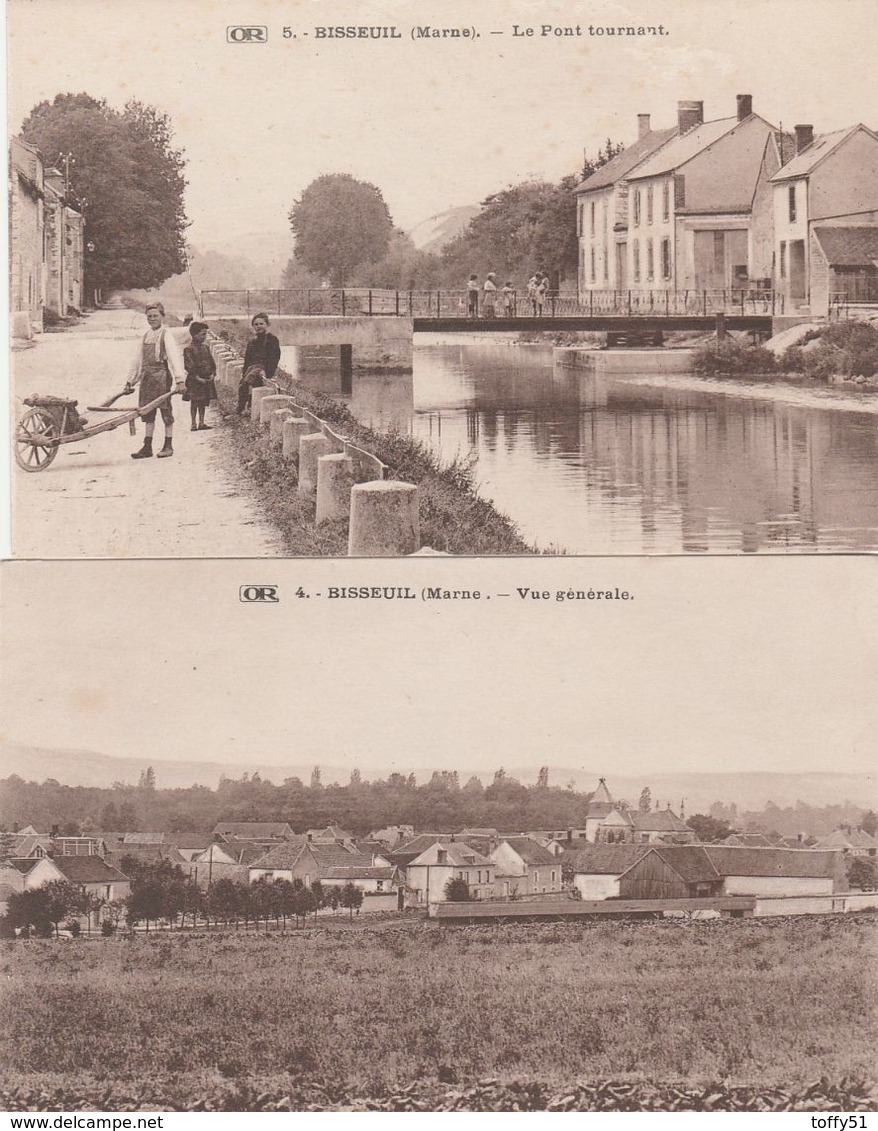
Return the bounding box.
[11,310,283,558]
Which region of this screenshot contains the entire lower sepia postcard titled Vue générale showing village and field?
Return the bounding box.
[0,556,878,1112]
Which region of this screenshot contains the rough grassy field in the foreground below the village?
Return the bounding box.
[0,914,878,1111]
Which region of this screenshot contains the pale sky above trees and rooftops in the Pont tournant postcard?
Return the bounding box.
[7,0,878,248]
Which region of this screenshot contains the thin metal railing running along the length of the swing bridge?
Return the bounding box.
[199,287,784,322]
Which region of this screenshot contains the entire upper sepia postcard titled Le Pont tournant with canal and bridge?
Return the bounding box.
[7,0,878,559]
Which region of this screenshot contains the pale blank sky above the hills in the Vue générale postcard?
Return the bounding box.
[0,556,878,777]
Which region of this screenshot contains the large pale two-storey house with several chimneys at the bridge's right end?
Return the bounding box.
[576,94,782,298]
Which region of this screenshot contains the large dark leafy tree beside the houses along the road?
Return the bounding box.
[21,93,188,292]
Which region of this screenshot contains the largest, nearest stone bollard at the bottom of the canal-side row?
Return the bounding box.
[347,480,421,558]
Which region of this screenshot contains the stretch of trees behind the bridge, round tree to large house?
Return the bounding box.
[284,138,623,290]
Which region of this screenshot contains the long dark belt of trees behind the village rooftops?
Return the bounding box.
[0,767,878,840]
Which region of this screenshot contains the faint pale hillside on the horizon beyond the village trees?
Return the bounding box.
[0,744,878,813]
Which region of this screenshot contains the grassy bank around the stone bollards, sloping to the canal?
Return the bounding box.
[216,331,540,555]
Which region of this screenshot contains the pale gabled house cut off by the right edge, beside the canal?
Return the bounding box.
[771,123,878,316]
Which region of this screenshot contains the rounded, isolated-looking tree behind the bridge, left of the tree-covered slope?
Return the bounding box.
[290,173,394,286]
